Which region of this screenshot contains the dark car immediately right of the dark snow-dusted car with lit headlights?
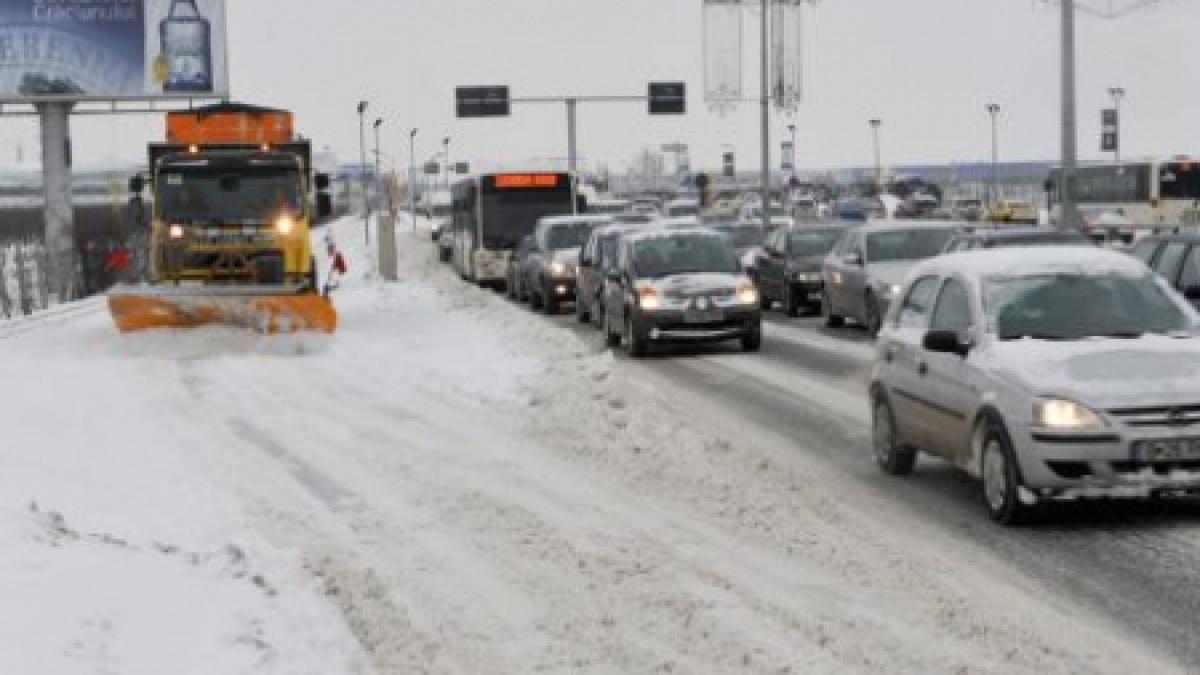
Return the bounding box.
[754,225,845,316]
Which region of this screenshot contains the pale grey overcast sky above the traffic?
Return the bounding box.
[0,0,1200,169]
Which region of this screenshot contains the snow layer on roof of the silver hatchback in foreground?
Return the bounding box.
[912,245,1147,279]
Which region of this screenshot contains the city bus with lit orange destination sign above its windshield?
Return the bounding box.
[450,172,575,286]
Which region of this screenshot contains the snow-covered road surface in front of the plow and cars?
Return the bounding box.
[0,216,1196,674]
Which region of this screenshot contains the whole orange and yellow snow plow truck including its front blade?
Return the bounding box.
[108,103,337,334]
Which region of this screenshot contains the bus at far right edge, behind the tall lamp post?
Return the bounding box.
[1046,157,1200,228]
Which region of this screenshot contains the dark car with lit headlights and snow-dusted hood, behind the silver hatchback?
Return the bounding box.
[601,228,762,357]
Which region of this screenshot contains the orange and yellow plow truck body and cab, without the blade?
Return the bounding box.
[131,103,331,292]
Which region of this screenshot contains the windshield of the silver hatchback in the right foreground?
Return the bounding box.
[984,273,1192,340]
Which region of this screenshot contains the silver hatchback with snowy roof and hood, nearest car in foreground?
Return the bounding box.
[870,246,1200,524]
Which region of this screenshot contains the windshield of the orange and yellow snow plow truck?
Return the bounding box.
[158,169,304,222]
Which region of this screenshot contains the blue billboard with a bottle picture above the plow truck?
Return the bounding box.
[0,0,229,102]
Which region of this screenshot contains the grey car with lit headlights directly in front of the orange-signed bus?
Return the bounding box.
[521,216,612,315]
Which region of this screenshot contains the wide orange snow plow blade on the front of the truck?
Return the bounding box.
[108,286,337,335]
